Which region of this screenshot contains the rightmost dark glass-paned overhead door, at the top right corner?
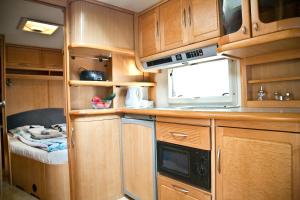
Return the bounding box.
[251,0,300,36]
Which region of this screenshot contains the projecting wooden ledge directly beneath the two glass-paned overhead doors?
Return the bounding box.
[217,28,300,58]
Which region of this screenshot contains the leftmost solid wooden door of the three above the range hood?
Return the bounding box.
[138,8,160,57]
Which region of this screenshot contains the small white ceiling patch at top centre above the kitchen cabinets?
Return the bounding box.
[97,0,160,12]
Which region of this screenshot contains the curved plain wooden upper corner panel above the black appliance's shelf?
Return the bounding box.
[70,1,134,50]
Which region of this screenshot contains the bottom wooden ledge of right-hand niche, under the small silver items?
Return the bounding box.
[247,100,300,108]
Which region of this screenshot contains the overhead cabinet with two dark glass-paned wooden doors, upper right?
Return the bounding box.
[219,0,300,44]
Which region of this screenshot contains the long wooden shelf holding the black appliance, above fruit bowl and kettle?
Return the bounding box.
[69,80,156,87]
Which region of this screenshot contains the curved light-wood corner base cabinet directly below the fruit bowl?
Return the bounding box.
[68,115,123,200]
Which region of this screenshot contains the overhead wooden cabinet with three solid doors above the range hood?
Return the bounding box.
[139,0,220,57]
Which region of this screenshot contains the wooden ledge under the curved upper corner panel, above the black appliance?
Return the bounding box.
[69,44,134,56]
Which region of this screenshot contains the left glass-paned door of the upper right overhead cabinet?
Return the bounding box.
[219,0,251,44]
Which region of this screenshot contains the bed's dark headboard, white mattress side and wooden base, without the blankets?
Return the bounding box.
[7,108,70,200]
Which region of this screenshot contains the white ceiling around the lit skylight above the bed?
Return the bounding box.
[0,0,64,49]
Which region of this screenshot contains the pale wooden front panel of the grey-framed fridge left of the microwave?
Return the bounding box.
[122,119,156,200]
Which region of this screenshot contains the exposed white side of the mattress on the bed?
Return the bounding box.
[9,137,68,165]
